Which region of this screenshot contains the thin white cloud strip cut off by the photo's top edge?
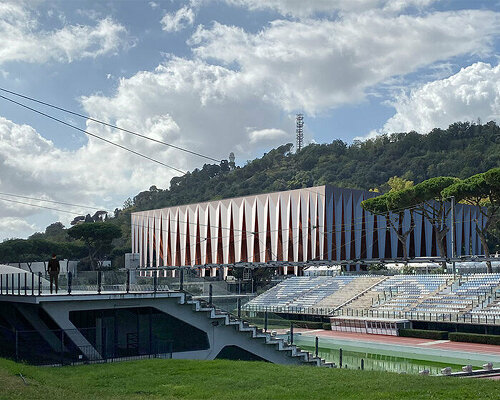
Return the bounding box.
[219,0,438,17]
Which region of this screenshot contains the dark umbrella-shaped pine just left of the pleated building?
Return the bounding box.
[68,222,122,270]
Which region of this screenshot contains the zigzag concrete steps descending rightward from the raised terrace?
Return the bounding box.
[179,294,336,368]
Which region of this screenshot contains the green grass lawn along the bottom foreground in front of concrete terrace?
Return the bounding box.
[0,359,500,400]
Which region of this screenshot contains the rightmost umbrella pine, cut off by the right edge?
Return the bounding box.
[441,168,500,273]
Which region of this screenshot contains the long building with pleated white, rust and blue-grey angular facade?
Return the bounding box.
[131,186,482,267]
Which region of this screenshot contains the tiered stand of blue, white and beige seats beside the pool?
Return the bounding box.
[246,274,500,316]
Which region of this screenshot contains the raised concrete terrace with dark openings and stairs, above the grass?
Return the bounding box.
[0,269,333,367]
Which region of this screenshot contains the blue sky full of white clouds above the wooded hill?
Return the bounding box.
[0,0,500,240]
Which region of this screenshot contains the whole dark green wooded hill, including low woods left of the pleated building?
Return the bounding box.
[0,122,500,269]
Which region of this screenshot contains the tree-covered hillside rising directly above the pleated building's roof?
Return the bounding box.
[130,122,500,211]
